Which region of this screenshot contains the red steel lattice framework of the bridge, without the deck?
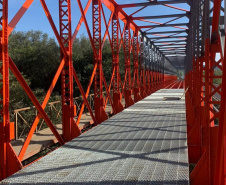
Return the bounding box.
[0,0,226,185]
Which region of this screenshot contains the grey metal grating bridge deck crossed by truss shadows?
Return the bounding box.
[0,89,189,185]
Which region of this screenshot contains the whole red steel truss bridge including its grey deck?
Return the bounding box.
[0,0,226,185]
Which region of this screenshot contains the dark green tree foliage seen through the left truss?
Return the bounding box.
[9,31,129,107]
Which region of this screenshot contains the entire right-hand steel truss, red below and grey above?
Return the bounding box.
[185,0,226,185]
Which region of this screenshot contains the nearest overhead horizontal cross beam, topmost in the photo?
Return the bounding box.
[119,0,190,8]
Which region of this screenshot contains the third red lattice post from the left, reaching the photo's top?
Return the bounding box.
[92,0,108,124]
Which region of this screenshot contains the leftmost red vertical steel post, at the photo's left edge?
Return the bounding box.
[0,0,22,181]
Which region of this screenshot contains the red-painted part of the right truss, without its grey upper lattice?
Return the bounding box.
[185,0,226,185]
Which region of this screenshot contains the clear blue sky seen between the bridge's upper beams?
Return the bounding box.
[9,0,189,40]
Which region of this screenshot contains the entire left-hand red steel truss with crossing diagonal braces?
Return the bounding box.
[0,0,180,180]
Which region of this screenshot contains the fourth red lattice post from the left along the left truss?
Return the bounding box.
[112,12,124,113]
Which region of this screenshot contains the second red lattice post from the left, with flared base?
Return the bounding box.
[59,0,80,141]
